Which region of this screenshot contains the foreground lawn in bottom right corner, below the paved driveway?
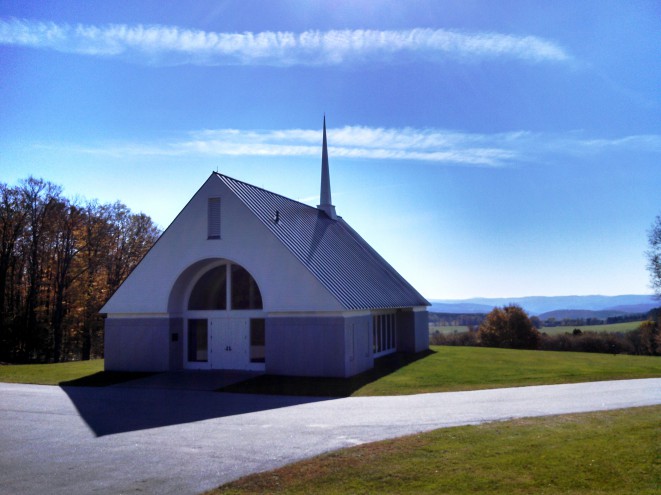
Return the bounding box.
[213,406,661,495]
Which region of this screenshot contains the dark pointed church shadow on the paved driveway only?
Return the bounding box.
[61,376,330,437]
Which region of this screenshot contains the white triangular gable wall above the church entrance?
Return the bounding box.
[101,174,341,315]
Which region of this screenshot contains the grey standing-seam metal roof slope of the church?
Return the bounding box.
[215,173,429,309]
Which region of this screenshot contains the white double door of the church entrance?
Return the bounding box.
[209,318,250,370]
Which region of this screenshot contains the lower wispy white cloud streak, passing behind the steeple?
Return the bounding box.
[43,126,661,167]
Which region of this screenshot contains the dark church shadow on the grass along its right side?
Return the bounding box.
[220,350,435,398]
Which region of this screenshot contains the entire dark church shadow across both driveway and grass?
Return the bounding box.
[60,351,434,436]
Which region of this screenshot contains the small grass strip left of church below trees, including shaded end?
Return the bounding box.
[0,359,152,387]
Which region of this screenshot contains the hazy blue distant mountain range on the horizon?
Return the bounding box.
[429,295,661,315]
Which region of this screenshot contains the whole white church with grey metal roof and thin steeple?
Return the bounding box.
[101,119,429,377]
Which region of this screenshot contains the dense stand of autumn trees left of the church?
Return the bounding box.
[0,177,160,363]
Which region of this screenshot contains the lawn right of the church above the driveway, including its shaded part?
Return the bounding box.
[225,346,661,397]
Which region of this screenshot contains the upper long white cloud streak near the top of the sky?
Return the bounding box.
[0,18,571,66]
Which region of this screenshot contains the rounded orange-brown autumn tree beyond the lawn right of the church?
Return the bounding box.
[478,304,540,349]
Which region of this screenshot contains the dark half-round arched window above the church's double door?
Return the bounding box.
[188,264,262,311]
